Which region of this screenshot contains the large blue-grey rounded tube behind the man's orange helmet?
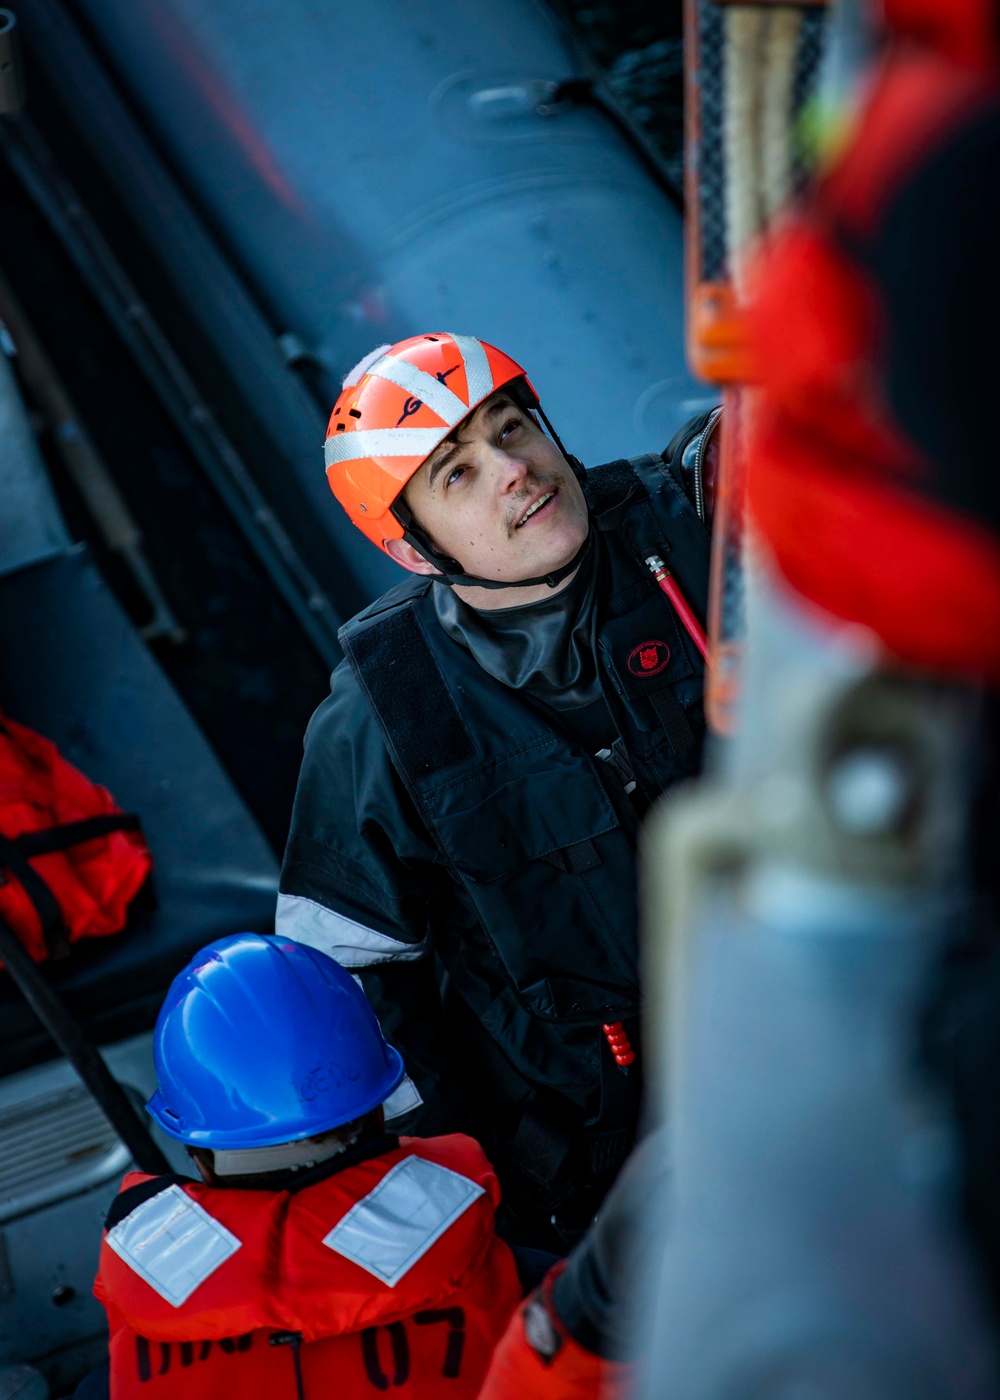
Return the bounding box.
[50,0,710,595]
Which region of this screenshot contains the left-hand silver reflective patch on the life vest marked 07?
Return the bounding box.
[105,1184,242,1308]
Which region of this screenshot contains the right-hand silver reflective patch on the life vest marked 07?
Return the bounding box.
[324,1156,483,1288]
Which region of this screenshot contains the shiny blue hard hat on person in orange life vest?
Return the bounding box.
[147,934,403,1148]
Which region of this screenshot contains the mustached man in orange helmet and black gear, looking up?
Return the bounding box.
[277,333,710,1249]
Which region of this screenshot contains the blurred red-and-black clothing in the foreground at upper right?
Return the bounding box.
[748,0,1000,683]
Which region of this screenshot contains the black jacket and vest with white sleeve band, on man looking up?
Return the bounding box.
[277,431,709,1232]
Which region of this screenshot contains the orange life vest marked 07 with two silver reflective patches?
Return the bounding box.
[94,1135,521,1400]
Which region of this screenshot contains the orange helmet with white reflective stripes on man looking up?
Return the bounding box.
[326,333,538,549]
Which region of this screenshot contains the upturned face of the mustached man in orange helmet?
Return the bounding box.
[405,389,590,606]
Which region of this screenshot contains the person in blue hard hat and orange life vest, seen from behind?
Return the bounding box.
[78,934,521,1400]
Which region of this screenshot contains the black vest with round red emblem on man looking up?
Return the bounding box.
[340,456,709,1105]
